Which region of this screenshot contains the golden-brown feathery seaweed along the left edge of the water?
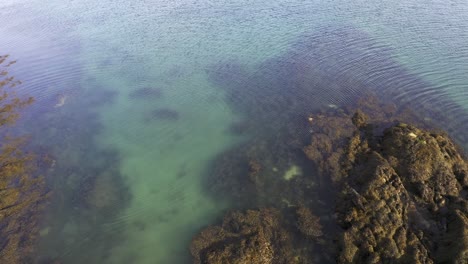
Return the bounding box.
[0,56,50,263]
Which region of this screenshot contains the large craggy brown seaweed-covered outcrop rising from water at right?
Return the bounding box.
[304,108,468,263]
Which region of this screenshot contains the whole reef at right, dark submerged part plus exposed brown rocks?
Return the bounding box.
[190,28,468,263]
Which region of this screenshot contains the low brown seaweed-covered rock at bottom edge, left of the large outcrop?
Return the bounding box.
[190,209,306,264]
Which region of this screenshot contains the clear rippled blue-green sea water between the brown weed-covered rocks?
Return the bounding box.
[0,0,468,263]
